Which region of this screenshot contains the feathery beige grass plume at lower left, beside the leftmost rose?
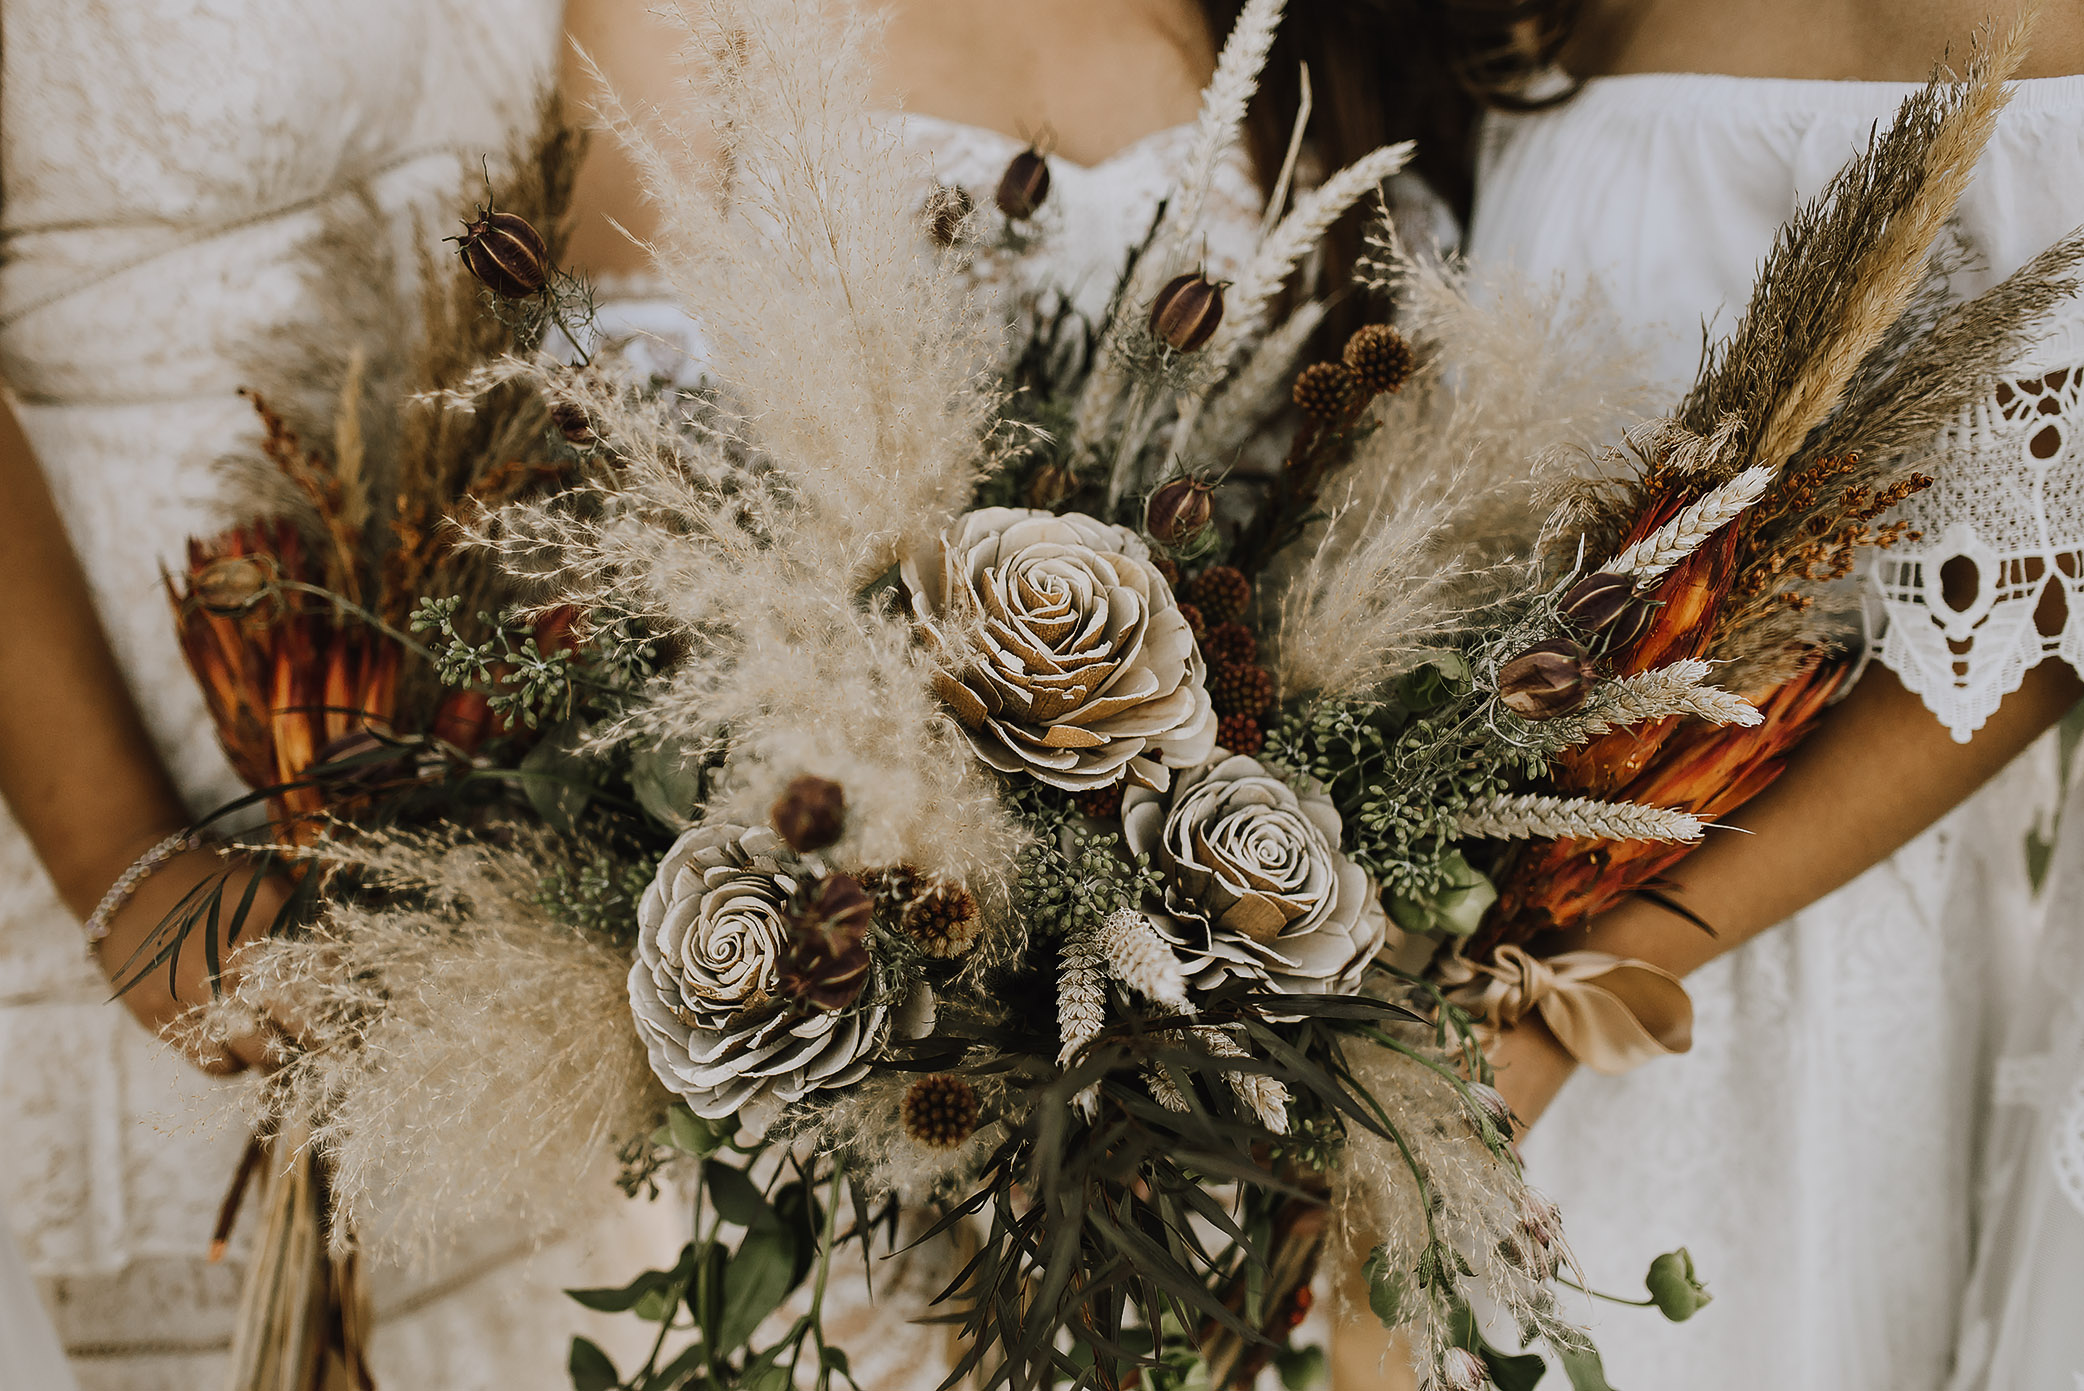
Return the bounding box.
[203,830,667,1255]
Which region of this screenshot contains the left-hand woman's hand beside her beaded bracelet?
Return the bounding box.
[96,847,290,1076]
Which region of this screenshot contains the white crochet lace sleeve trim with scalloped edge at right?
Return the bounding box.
[1869,302,2084,742]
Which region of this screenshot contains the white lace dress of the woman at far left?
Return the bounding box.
[0,0,677,1391]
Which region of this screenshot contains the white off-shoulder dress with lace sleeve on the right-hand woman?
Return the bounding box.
[1471,75,2084,1391]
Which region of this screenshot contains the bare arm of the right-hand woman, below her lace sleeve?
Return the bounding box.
[1490,661,2084,1124]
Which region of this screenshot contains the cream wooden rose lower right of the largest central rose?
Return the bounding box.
[1121,749,1388,995]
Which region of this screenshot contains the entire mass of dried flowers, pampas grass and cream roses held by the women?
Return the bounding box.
[154,0,2076,1391]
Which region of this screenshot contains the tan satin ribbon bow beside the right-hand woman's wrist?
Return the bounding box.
[1448,947,1692,1076]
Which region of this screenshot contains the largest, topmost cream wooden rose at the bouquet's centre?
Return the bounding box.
[902,507,1215,792]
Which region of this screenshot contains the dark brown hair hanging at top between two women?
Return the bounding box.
[1202,0,1582,300]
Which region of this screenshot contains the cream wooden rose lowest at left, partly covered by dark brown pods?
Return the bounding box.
[629,826,890,1130]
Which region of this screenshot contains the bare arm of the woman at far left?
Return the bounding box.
[0,405,279,1072]
